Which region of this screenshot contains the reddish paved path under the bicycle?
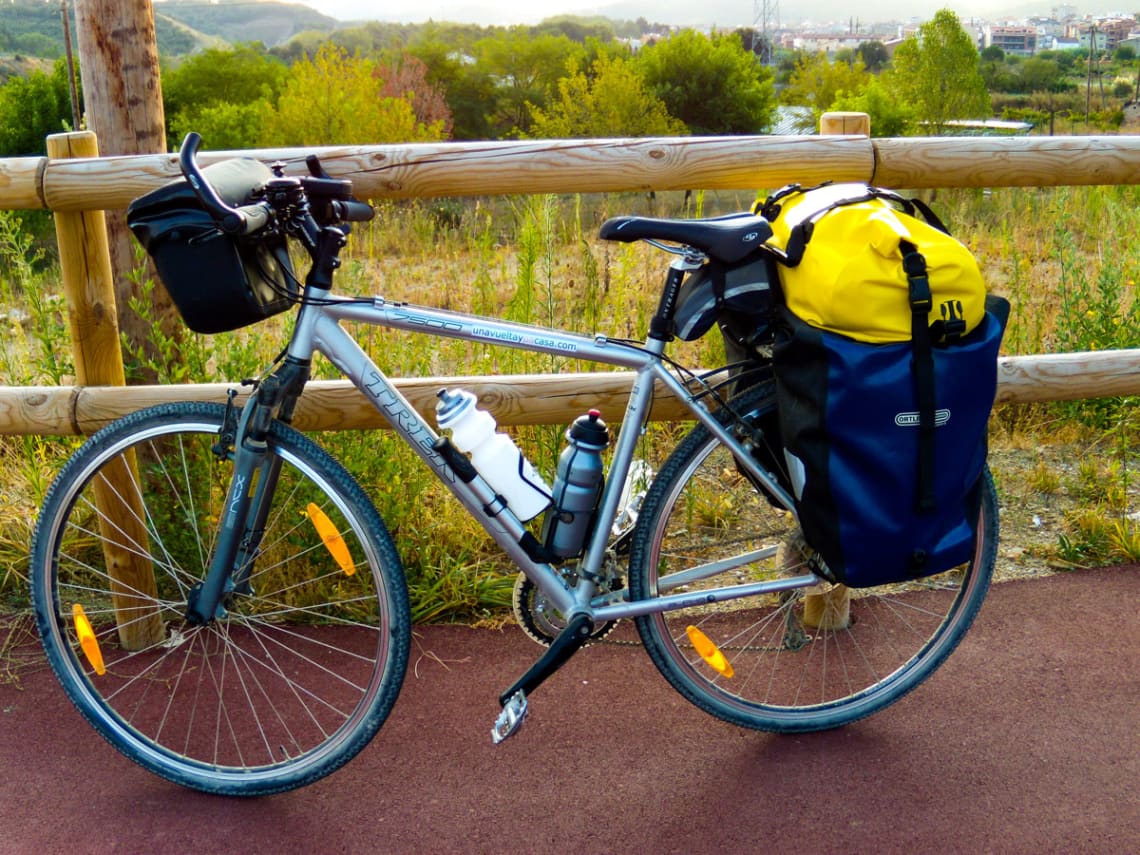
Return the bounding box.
[0,568,1140,855]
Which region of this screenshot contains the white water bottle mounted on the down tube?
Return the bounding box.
[435,389,551,522]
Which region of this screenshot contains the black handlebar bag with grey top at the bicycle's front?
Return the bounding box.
[127,160,296,333]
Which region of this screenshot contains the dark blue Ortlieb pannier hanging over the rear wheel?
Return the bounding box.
[773,296,1009,587]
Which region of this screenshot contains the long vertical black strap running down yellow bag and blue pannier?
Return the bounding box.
[899,241,935,513]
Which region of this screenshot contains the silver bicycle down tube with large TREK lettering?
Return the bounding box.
[314,316,573,609]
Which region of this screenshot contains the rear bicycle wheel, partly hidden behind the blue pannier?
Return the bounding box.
[629,382,998,733]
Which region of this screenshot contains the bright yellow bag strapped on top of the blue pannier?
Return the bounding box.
[757,184,986,343]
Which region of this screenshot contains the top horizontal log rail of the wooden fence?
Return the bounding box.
[0,136,1140,211]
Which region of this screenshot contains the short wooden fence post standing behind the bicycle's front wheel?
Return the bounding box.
[48,131,165,650]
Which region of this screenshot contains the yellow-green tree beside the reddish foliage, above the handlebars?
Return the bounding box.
[266,43,443,146]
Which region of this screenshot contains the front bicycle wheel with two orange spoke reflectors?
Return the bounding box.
[31,404,410,796]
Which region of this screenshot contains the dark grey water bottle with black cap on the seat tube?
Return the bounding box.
[543,409,610,559]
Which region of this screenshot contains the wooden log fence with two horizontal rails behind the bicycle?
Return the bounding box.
[0,114,1140,434]
